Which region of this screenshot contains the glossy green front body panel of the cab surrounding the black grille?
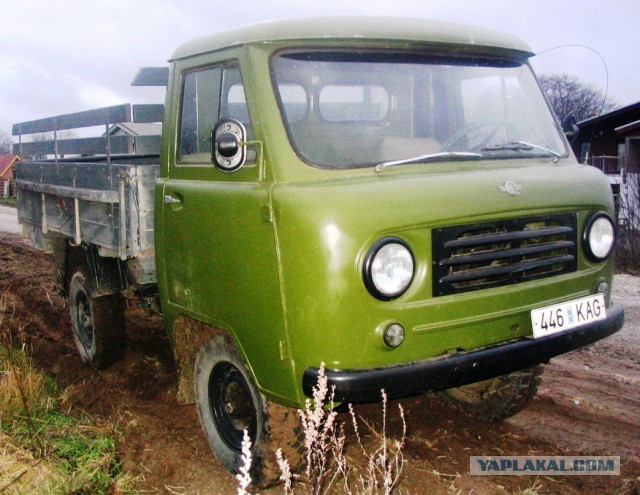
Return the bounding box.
[273,160,611,390]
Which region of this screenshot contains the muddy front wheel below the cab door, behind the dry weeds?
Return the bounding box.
[195,335,304,488]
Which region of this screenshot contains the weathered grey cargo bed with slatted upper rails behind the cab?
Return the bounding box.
[14,105,161,285]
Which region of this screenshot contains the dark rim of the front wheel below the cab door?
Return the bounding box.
[209,363,257,452]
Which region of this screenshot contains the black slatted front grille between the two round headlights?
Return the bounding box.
[431,213,578,296]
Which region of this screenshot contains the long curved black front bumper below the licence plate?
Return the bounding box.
[302,306,624,402]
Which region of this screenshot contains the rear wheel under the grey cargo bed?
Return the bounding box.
[69,269,126,369]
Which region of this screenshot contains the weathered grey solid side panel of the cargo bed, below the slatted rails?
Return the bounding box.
[16,162,158,260]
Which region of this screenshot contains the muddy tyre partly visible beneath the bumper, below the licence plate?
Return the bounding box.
[440,366,542,422]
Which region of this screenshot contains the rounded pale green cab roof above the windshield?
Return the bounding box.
[171,16,532,60]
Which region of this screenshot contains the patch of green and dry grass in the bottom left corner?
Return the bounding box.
[0,298,140,495]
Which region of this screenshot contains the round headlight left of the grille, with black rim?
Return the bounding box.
[363,237,414,301]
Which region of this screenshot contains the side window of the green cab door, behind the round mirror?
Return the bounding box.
[178,65,252,165]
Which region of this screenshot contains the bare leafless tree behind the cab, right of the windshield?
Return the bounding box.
[538,74,616,122]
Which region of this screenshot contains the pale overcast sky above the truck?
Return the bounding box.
[0,0,640,140]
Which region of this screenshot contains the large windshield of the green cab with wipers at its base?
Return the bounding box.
[273,51,566,169]
